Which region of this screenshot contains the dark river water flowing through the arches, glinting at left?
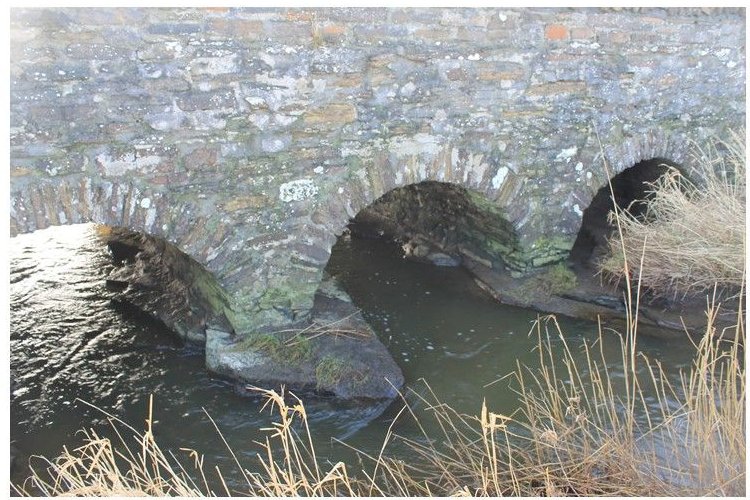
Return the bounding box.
[9,225,692,492]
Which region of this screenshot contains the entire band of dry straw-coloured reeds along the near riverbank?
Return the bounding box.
[17,292,745,497]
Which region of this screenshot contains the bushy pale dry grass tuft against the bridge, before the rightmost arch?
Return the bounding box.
[600,133,746,296]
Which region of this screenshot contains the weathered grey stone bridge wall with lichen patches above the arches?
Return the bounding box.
[10,8,745,332]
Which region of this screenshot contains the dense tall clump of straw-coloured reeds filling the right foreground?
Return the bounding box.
[358,296,745,496]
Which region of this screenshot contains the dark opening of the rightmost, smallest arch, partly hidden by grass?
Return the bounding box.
[570,158,679,268]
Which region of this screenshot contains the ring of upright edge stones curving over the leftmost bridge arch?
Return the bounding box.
[10,177,241,336]
